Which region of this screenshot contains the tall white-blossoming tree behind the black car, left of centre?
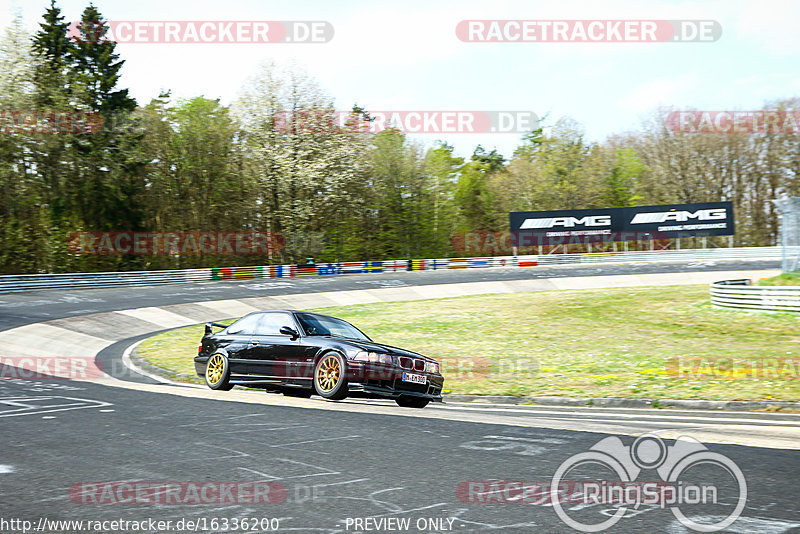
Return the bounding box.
[233,63,369,261]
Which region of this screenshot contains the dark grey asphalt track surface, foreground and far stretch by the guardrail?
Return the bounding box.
[0,262,800,534]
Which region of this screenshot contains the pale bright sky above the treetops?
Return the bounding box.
[0,0,800,157]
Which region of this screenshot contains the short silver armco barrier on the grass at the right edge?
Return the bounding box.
[711,280,800,312]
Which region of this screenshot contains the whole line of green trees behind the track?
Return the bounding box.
[0,0,800,273]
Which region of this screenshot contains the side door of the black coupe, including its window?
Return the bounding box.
[248,312,300,378]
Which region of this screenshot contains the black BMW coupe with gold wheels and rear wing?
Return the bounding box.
[194,310,444,408]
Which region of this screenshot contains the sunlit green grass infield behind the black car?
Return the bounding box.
[138,285,800,401]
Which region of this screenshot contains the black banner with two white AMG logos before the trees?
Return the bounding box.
[509,202,734,247]
